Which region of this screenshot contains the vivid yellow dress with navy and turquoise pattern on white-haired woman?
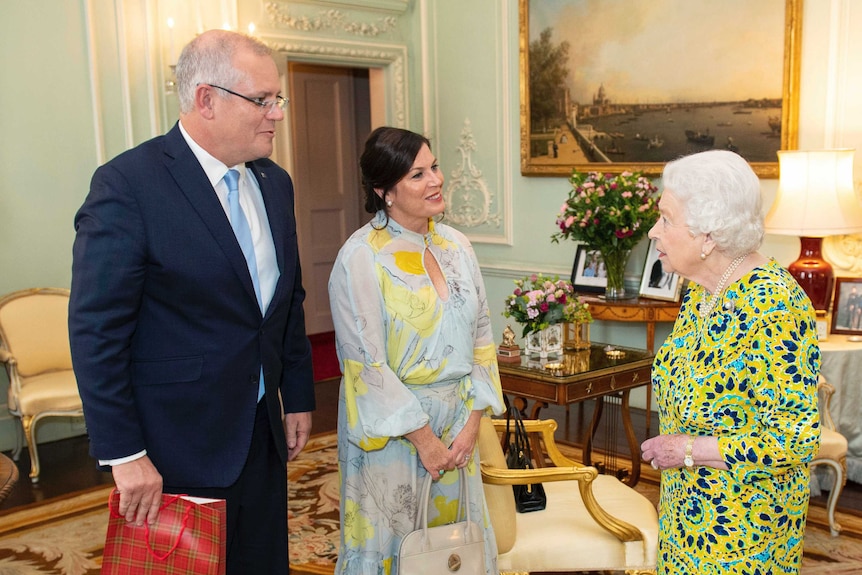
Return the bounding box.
[652,260,820,575]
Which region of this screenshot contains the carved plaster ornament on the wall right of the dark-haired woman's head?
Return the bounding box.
[445,118,502,228]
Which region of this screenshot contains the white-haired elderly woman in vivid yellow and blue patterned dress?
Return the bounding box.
[641,151,820,574]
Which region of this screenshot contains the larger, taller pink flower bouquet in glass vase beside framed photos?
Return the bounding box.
[551,170,659,299]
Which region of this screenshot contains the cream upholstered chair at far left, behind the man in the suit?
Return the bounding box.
[0,288,83,483]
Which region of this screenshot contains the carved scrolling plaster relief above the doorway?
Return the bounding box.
[264,2,398,38]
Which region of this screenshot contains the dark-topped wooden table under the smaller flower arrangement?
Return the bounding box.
[499,343,653,485]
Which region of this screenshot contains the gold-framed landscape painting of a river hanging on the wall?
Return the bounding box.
[519,0,802,178]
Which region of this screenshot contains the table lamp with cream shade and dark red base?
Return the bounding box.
[766,149,862,312]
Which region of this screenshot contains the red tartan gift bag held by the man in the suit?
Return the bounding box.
[102,489,227,575]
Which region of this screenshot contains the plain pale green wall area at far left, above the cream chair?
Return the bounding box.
[0,0,97,293]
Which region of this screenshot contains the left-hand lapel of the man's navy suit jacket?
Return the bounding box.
[165,125,258,308]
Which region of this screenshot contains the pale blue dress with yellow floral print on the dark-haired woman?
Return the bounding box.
[329,212,504,575]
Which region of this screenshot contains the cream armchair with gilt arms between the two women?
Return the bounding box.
[479,418,658,573]
